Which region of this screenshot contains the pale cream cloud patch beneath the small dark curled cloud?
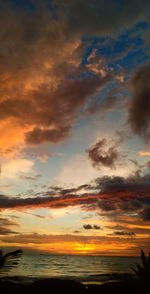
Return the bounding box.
[54,146,135,187]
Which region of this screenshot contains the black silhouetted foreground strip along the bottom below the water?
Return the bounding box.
[0,279,150,294]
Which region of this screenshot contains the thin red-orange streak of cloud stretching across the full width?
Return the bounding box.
[0,190,149,212]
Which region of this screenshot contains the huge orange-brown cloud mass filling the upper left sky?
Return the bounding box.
[0,1,110,154]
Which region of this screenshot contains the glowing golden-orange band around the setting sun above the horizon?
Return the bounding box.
[1,234,150,255]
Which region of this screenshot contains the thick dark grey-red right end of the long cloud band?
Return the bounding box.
[97,174,150,219]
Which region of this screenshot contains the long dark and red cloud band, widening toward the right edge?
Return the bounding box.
[0,174,150,224]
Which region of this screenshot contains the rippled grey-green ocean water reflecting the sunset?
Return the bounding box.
[4,254,140,280]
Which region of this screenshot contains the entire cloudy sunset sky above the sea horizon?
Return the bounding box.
[0,0,150,256]
